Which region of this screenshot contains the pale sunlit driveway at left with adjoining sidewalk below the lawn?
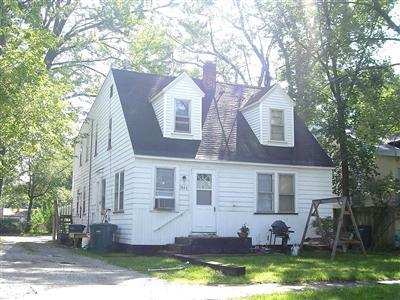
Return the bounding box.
[0,237,376,300]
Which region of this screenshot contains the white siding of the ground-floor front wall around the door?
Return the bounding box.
[131,156,332,245]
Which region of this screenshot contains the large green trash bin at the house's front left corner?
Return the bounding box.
[89,223,117,252]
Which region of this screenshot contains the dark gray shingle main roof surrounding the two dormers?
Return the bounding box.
[112,69,332,167]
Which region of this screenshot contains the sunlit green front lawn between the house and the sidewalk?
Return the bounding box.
[80,251,400,284]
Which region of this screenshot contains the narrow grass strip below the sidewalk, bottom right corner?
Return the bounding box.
[244,285,400,300]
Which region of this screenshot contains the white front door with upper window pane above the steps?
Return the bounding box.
[192,170,216,233]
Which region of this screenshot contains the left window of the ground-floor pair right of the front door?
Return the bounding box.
[257,174,275,213]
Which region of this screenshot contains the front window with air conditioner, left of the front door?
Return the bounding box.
[154,168,175,210]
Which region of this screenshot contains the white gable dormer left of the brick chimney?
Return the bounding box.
[150,73,204,140]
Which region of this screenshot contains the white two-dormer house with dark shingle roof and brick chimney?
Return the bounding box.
[73,63,332,245]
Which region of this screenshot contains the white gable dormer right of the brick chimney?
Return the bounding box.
[241,84,295,147]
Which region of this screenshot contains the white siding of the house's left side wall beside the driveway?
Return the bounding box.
[72,72,134,243]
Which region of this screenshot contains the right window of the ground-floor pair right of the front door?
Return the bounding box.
[279,174,295,213]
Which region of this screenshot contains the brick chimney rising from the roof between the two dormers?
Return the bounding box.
[202,61,217,124]
